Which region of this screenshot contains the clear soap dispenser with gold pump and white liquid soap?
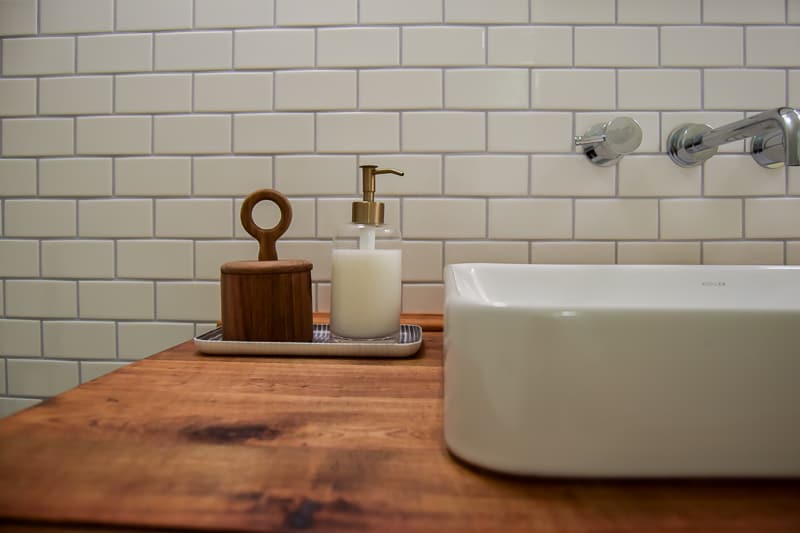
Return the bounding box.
[330,165,403,341]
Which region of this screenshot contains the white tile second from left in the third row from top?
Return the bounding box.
[39,76,112,115]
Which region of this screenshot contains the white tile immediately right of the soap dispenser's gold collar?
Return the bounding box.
[403,198,486,239]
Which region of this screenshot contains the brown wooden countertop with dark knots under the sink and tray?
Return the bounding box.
[0,318,800,533]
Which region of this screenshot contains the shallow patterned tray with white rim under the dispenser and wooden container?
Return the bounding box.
[194,324,422,357]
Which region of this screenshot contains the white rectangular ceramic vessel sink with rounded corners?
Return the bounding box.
[444,264,800,477]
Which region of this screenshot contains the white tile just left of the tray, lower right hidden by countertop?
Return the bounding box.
[117,322,194,360]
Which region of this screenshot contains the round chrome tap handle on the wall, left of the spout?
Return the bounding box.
[575,117,642,167]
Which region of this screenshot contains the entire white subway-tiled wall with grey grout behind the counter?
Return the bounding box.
[0,0,800,415]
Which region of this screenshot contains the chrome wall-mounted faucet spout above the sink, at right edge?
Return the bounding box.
[667,107,800,168]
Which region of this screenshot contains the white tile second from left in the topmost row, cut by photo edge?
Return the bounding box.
[39,0,114,33]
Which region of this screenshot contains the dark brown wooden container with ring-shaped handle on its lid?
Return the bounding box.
[225,189,313,342]
